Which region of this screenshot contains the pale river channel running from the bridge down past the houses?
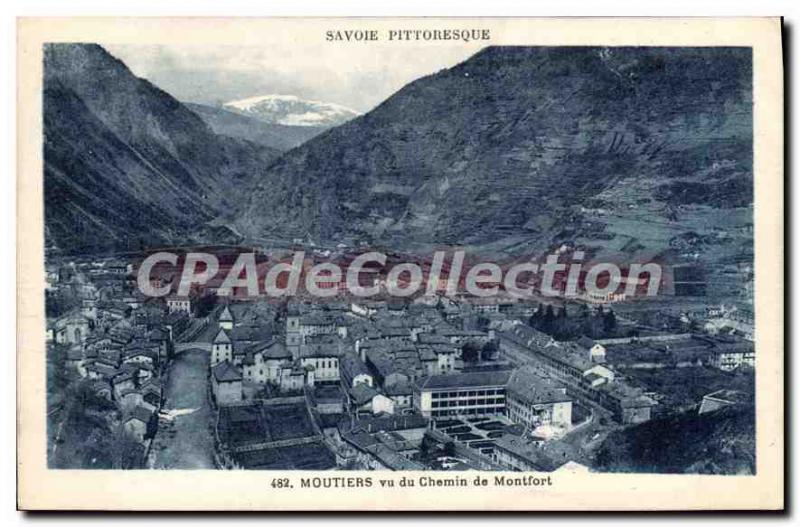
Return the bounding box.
[152,349,215,469]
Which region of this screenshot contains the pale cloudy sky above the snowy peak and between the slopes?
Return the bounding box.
[104,43,480,112]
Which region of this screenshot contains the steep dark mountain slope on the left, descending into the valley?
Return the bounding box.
[43,44,278,252]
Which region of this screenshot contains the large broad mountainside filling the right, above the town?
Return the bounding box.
[237,46,752,268]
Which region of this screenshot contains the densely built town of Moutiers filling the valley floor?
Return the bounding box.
[46,250,755,472]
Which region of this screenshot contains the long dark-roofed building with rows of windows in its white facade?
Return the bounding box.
[414,370,511,419]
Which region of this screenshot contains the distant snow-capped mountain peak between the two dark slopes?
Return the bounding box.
[223,95,359,127]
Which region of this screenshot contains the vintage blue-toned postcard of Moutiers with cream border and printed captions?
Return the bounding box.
[17,18,784,511]
